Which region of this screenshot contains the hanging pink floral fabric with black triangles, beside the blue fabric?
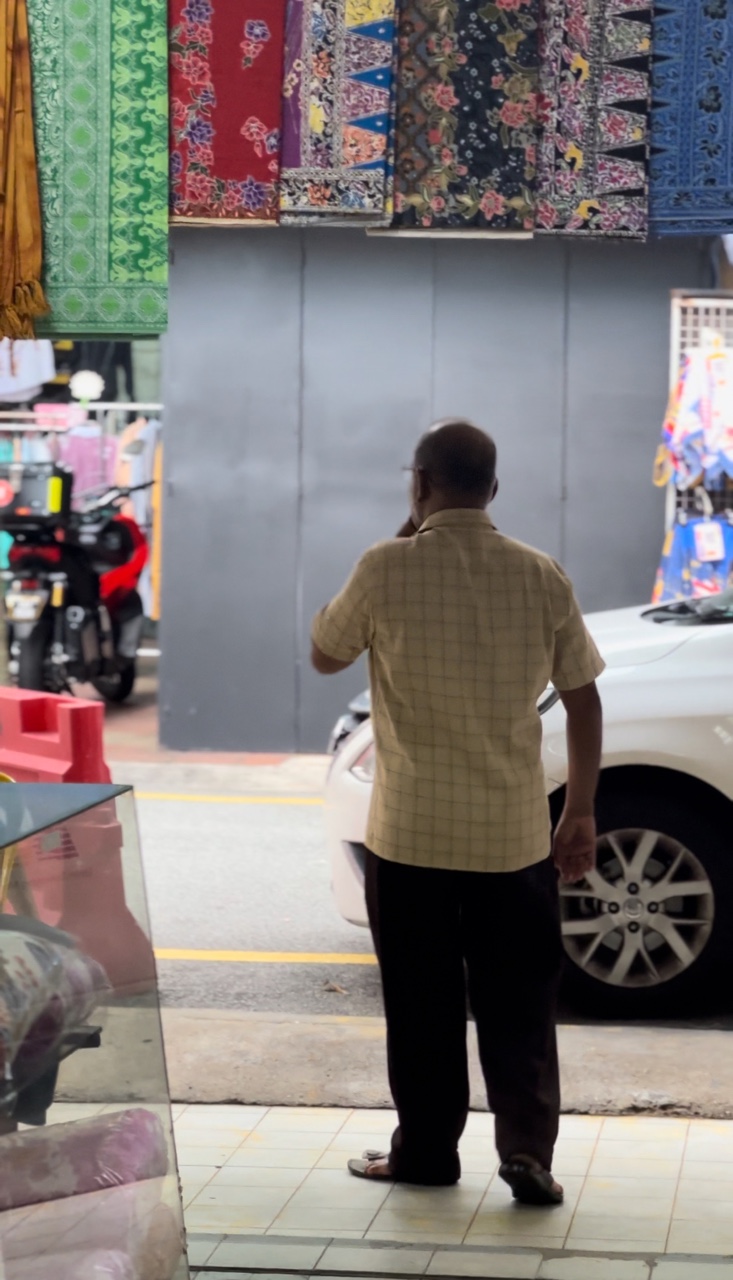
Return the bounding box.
[537,0,651,239]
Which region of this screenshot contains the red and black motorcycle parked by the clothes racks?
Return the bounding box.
[0,462,150,703]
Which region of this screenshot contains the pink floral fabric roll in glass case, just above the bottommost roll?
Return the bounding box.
[0,1108,169,1208]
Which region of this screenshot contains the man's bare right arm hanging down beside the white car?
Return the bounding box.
[553,680,603,884]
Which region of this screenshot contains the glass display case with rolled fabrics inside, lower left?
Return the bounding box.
[0,785,188,1280]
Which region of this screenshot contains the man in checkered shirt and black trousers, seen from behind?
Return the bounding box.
[312,421,604,1204]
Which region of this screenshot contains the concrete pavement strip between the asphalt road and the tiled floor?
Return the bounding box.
[58,1004,733,1120]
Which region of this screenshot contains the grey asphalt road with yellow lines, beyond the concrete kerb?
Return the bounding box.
[128,762,733,1029]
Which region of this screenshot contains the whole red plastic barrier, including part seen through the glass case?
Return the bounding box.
[0,689,155,995]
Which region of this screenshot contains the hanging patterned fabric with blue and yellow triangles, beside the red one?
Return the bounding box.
[280,0,395,224]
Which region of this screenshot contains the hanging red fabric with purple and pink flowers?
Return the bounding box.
[169,0,285,223]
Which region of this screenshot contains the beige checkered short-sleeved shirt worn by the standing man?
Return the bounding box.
[313,509,604,872]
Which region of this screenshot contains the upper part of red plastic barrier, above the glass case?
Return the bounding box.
[0,689,111,782]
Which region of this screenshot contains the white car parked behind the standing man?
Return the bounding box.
[326,591,733,1018]
